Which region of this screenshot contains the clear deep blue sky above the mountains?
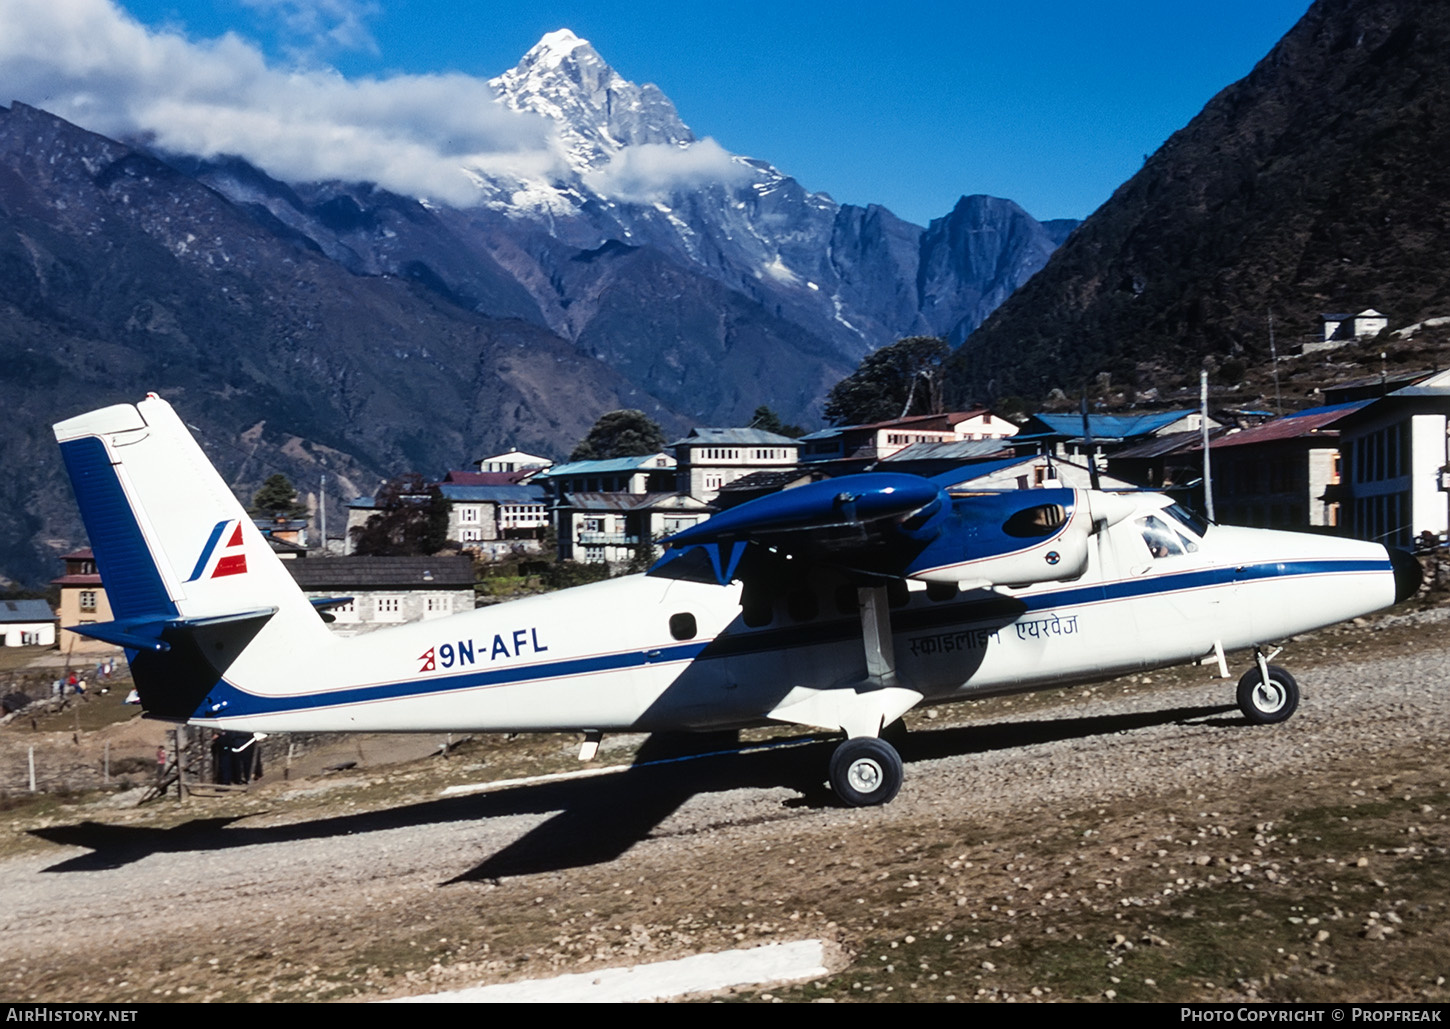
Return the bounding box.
[11,0,1309,223]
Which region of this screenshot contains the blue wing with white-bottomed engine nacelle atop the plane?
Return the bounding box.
[650,472,1117,586]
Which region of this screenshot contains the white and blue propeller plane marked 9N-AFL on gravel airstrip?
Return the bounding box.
[55,394,1420,804]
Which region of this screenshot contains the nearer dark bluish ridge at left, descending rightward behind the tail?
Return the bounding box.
[0,104,664,583]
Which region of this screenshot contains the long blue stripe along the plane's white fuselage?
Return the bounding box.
[193,559,1391,719]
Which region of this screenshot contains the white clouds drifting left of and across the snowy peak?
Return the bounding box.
[0,0,744,206]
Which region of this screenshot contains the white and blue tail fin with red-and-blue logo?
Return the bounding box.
[55,394,329,717]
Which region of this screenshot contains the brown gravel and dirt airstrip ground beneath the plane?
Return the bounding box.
[0,609,1450,1003]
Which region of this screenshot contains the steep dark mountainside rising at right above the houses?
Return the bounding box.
[954,0,1450,399]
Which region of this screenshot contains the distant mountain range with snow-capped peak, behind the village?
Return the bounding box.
[0,30,1072,583]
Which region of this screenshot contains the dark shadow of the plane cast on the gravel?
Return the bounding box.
[30,704,1244,883]
